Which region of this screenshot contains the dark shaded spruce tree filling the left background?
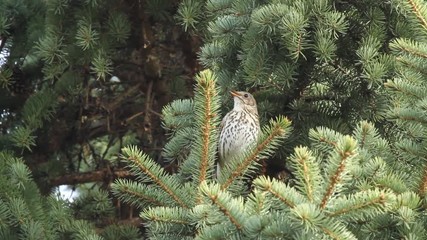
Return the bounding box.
[0,0,197,239]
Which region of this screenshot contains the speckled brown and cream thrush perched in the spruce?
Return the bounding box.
[217,91,261,177]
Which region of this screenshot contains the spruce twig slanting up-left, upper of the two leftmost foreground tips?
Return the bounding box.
[119,146,189,208]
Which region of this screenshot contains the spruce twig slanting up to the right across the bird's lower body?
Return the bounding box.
[220,116,291,190]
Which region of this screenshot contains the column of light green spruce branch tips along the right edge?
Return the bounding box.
[385,1,427,195]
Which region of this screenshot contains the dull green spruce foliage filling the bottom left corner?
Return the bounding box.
[0,151,105,240]
